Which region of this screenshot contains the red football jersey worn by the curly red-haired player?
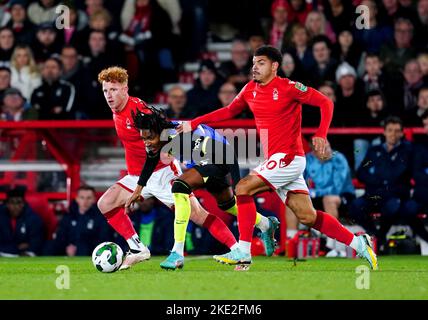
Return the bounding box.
[113,97,167,176]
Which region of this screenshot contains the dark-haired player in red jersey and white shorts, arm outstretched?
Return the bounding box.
[179,46,377,270]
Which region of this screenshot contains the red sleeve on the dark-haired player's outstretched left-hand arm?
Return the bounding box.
[191,84,248,130]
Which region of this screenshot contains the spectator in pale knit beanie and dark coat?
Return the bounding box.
[333,62,364,126]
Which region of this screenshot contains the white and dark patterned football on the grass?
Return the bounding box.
[92,242,123,272]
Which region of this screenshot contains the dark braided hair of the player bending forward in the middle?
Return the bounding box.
[131,106,176,134]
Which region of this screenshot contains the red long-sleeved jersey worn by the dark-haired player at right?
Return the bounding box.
[191,77,333,157]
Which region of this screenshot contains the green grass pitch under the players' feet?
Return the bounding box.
[0,256,428,300]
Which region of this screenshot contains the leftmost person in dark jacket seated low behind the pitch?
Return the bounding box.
[0,189,44,256]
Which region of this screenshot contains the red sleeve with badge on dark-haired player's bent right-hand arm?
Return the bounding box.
[288,81,334,139]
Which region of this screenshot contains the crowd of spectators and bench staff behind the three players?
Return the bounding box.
[0,0,428,255]
